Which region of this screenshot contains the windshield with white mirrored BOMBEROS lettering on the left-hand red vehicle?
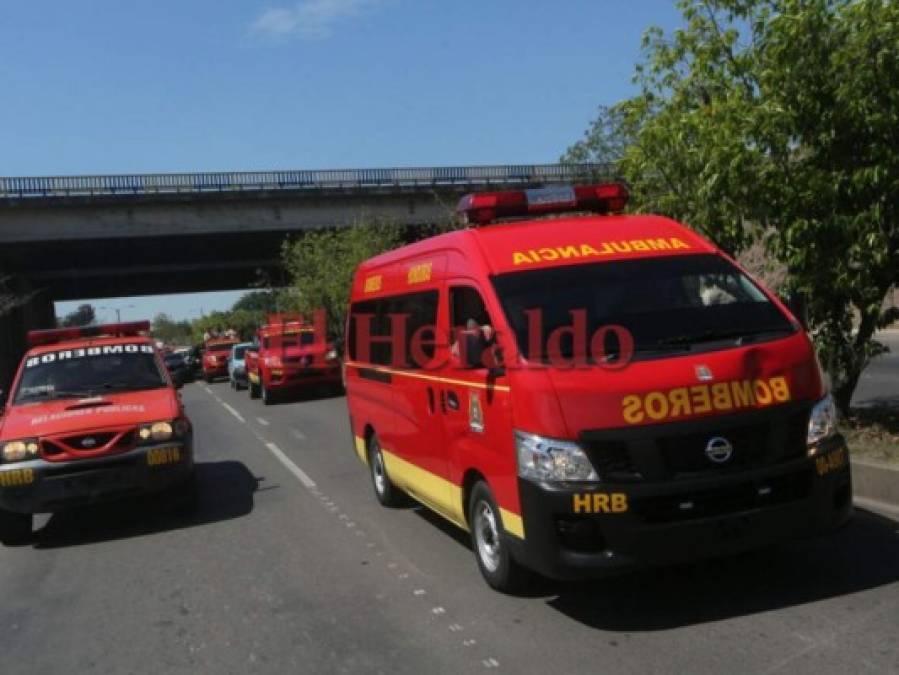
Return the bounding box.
[14,350,166,403]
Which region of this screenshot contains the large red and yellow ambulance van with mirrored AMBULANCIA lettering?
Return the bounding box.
[346,184,852,590]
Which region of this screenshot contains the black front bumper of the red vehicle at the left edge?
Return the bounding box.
[0,440,194,513]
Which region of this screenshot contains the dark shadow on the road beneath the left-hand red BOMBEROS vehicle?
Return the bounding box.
[33,461,259,548]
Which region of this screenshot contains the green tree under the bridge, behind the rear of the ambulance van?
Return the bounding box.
[282,222,403,334]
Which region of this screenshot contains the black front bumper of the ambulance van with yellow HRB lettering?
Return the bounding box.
[507,437,852,579]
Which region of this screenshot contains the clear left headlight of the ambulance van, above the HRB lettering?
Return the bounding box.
[515,431,599,481]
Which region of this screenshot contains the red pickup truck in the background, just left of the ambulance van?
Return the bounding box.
[244,315,341,405]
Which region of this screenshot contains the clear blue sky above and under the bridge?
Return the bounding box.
[0,0,679,316]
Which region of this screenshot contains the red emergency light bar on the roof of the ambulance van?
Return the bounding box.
[456,183,628,225]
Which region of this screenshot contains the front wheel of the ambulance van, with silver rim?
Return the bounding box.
[468,481,528,593]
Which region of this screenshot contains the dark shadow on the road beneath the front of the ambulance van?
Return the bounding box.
[533,509,899,631]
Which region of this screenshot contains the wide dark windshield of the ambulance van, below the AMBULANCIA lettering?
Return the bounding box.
[493,255,796,361]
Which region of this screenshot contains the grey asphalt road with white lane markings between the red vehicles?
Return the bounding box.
[0,383,899,675]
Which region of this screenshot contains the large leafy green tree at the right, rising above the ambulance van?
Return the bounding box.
[566,0,899,413]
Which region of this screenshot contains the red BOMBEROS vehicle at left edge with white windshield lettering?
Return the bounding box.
[0,321,195,543]
